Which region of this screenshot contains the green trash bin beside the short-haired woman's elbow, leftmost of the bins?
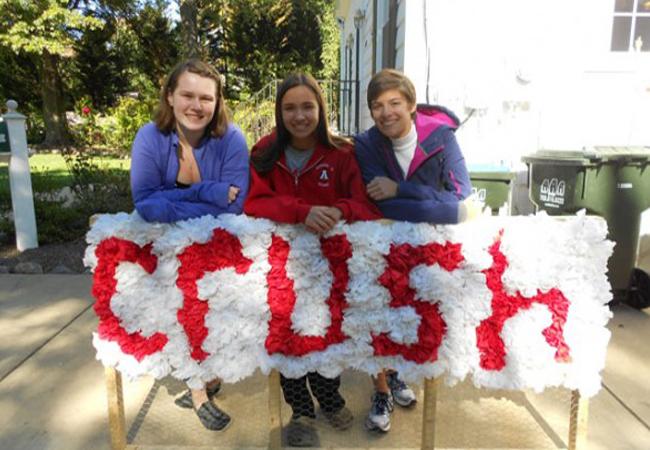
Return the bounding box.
[468,165,516,216]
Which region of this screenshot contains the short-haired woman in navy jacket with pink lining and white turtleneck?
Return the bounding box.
[355,69,479,432]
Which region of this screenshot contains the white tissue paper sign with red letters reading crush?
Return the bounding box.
[85,214,613,395]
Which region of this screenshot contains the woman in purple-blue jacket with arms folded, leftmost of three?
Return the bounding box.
[131,60,248,431]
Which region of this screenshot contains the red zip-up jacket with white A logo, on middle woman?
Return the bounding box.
[244,133,381,223]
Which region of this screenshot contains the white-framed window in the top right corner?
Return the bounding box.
[611,0,650,52]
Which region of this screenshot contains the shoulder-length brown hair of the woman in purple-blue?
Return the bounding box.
[154,59,229,137]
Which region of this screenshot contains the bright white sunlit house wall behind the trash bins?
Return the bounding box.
[404,0,650,166]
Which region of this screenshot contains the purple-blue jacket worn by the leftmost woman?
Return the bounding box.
[131,123,249,222]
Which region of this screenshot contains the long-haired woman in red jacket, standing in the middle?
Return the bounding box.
[244,74,381,447]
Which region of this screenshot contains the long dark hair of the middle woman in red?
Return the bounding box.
[251,73,350,173]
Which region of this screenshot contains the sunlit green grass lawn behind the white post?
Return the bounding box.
[0,153,131,199]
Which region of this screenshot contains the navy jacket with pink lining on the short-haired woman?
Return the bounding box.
[355,105,472,224]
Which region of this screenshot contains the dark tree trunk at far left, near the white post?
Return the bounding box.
[41,51,70,147]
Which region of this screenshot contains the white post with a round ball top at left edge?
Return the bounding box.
[2,100,38,252]
